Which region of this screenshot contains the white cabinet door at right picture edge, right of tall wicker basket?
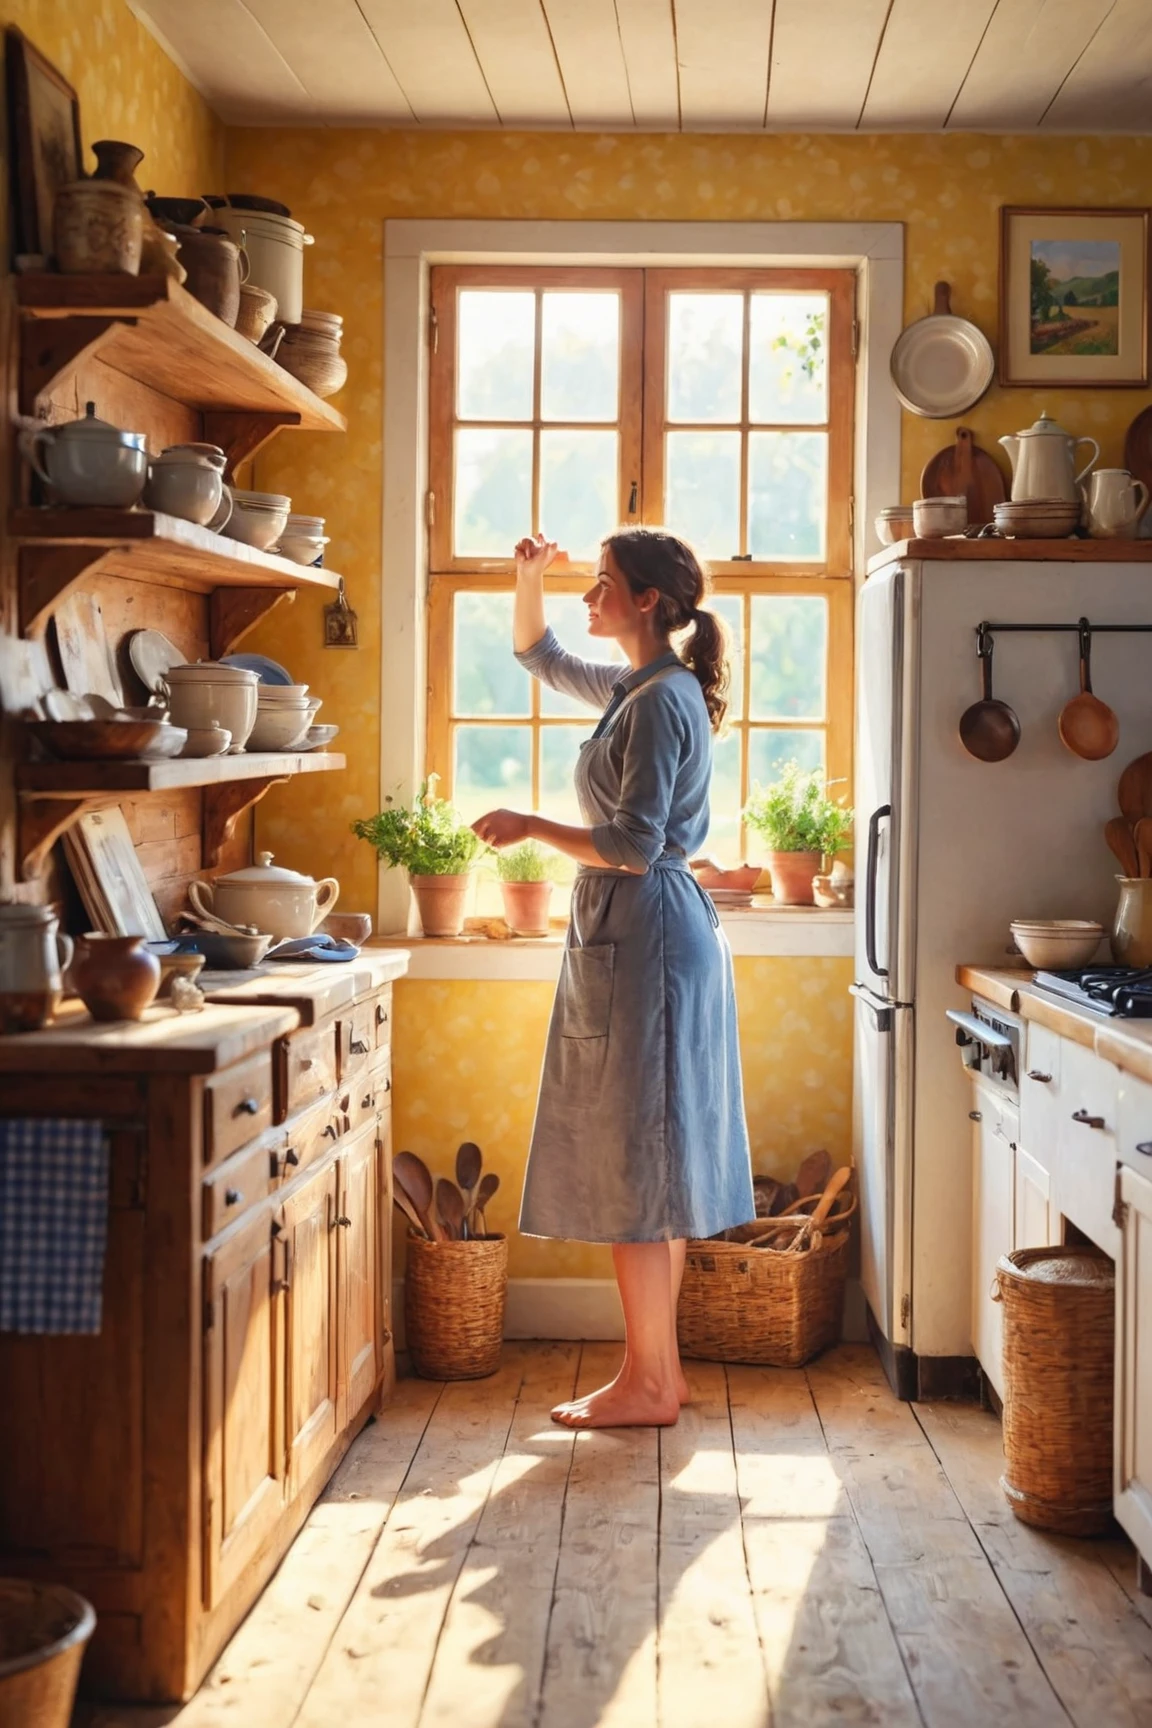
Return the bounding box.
[1114,1135,1152,1566]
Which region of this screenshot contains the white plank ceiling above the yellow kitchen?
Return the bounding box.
[130,0,1152,133]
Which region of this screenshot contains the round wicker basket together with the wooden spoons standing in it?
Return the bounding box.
[392,1140,508,1381]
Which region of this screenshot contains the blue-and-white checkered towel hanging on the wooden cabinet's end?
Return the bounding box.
[0,1116,109,1332]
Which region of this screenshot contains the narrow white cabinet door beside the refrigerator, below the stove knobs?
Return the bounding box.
[972,1080,1019,1398]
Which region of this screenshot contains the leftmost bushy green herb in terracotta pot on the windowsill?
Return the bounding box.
[352,774,487,937]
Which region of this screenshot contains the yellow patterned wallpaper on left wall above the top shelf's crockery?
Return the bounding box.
[0,0,225,251]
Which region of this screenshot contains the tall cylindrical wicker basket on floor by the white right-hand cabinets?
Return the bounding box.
[997,1248,1116,1536]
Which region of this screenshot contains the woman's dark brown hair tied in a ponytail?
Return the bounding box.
[604,529,729,733]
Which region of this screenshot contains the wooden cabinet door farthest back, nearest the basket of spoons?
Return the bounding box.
[337,1121,382,1427]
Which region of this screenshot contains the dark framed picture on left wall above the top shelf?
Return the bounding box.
[3,24,85,256]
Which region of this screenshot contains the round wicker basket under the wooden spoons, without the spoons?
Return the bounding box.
[404,1236,508,1381]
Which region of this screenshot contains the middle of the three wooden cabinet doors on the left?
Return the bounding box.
[282,1156,344,1495]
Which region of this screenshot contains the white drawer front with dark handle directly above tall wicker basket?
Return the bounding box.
[1055,1039,1119,1255]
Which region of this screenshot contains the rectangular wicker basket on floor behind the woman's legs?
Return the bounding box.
[677,1191,855,1369]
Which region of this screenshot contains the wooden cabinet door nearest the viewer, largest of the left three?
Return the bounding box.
[204,1206,285,1609]
